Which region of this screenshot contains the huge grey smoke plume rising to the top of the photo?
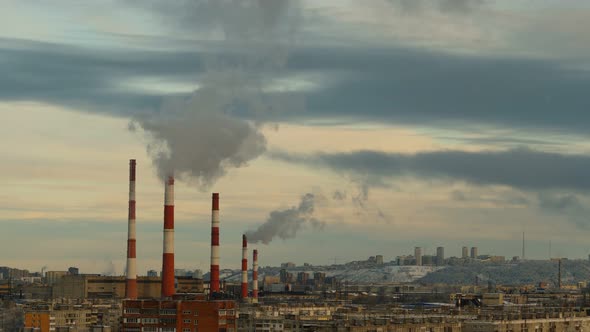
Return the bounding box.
[130,0,303,189]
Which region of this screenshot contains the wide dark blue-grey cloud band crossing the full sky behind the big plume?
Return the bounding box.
[0,23,590,135]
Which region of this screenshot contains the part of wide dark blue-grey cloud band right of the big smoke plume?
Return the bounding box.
[290,48,590,135]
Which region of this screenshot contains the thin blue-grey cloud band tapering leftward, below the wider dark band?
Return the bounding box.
[270,148,590,191]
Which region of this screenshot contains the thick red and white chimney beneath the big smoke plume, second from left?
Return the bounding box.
[162,176,174,297]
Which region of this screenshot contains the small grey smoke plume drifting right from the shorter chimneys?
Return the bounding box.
[246,193,324,244]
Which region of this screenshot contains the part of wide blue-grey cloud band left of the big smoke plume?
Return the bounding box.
[0,39,200,116]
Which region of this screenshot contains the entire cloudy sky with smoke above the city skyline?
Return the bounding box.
[0,0,590,274]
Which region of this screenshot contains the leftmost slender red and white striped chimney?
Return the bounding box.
[125,159,137,299]
